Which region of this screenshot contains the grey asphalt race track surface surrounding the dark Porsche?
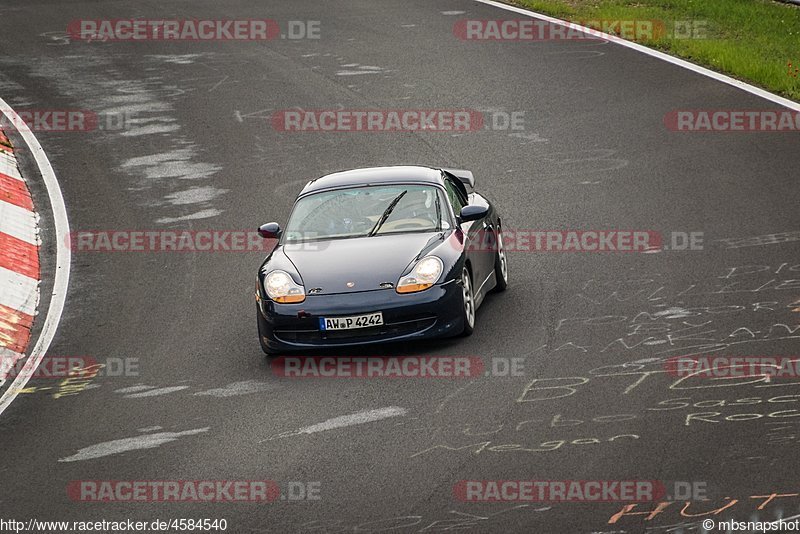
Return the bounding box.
[0,0,800,534]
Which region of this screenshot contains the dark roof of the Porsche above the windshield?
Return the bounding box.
[299,165,444,196]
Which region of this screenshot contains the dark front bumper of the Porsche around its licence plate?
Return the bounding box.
[258,281,464,352]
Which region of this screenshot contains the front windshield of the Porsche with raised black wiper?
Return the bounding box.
[284,184,450,243]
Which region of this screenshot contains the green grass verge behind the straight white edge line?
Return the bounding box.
[506,0,800,101]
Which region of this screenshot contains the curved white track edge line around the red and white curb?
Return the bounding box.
[0,102,72,414]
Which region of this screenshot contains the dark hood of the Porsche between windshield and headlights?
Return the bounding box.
[282,232,441,295]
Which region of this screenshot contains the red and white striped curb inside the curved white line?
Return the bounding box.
[0,129,40,386]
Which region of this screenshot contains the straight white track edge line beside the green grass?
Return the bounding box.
[474,0,800,111]
